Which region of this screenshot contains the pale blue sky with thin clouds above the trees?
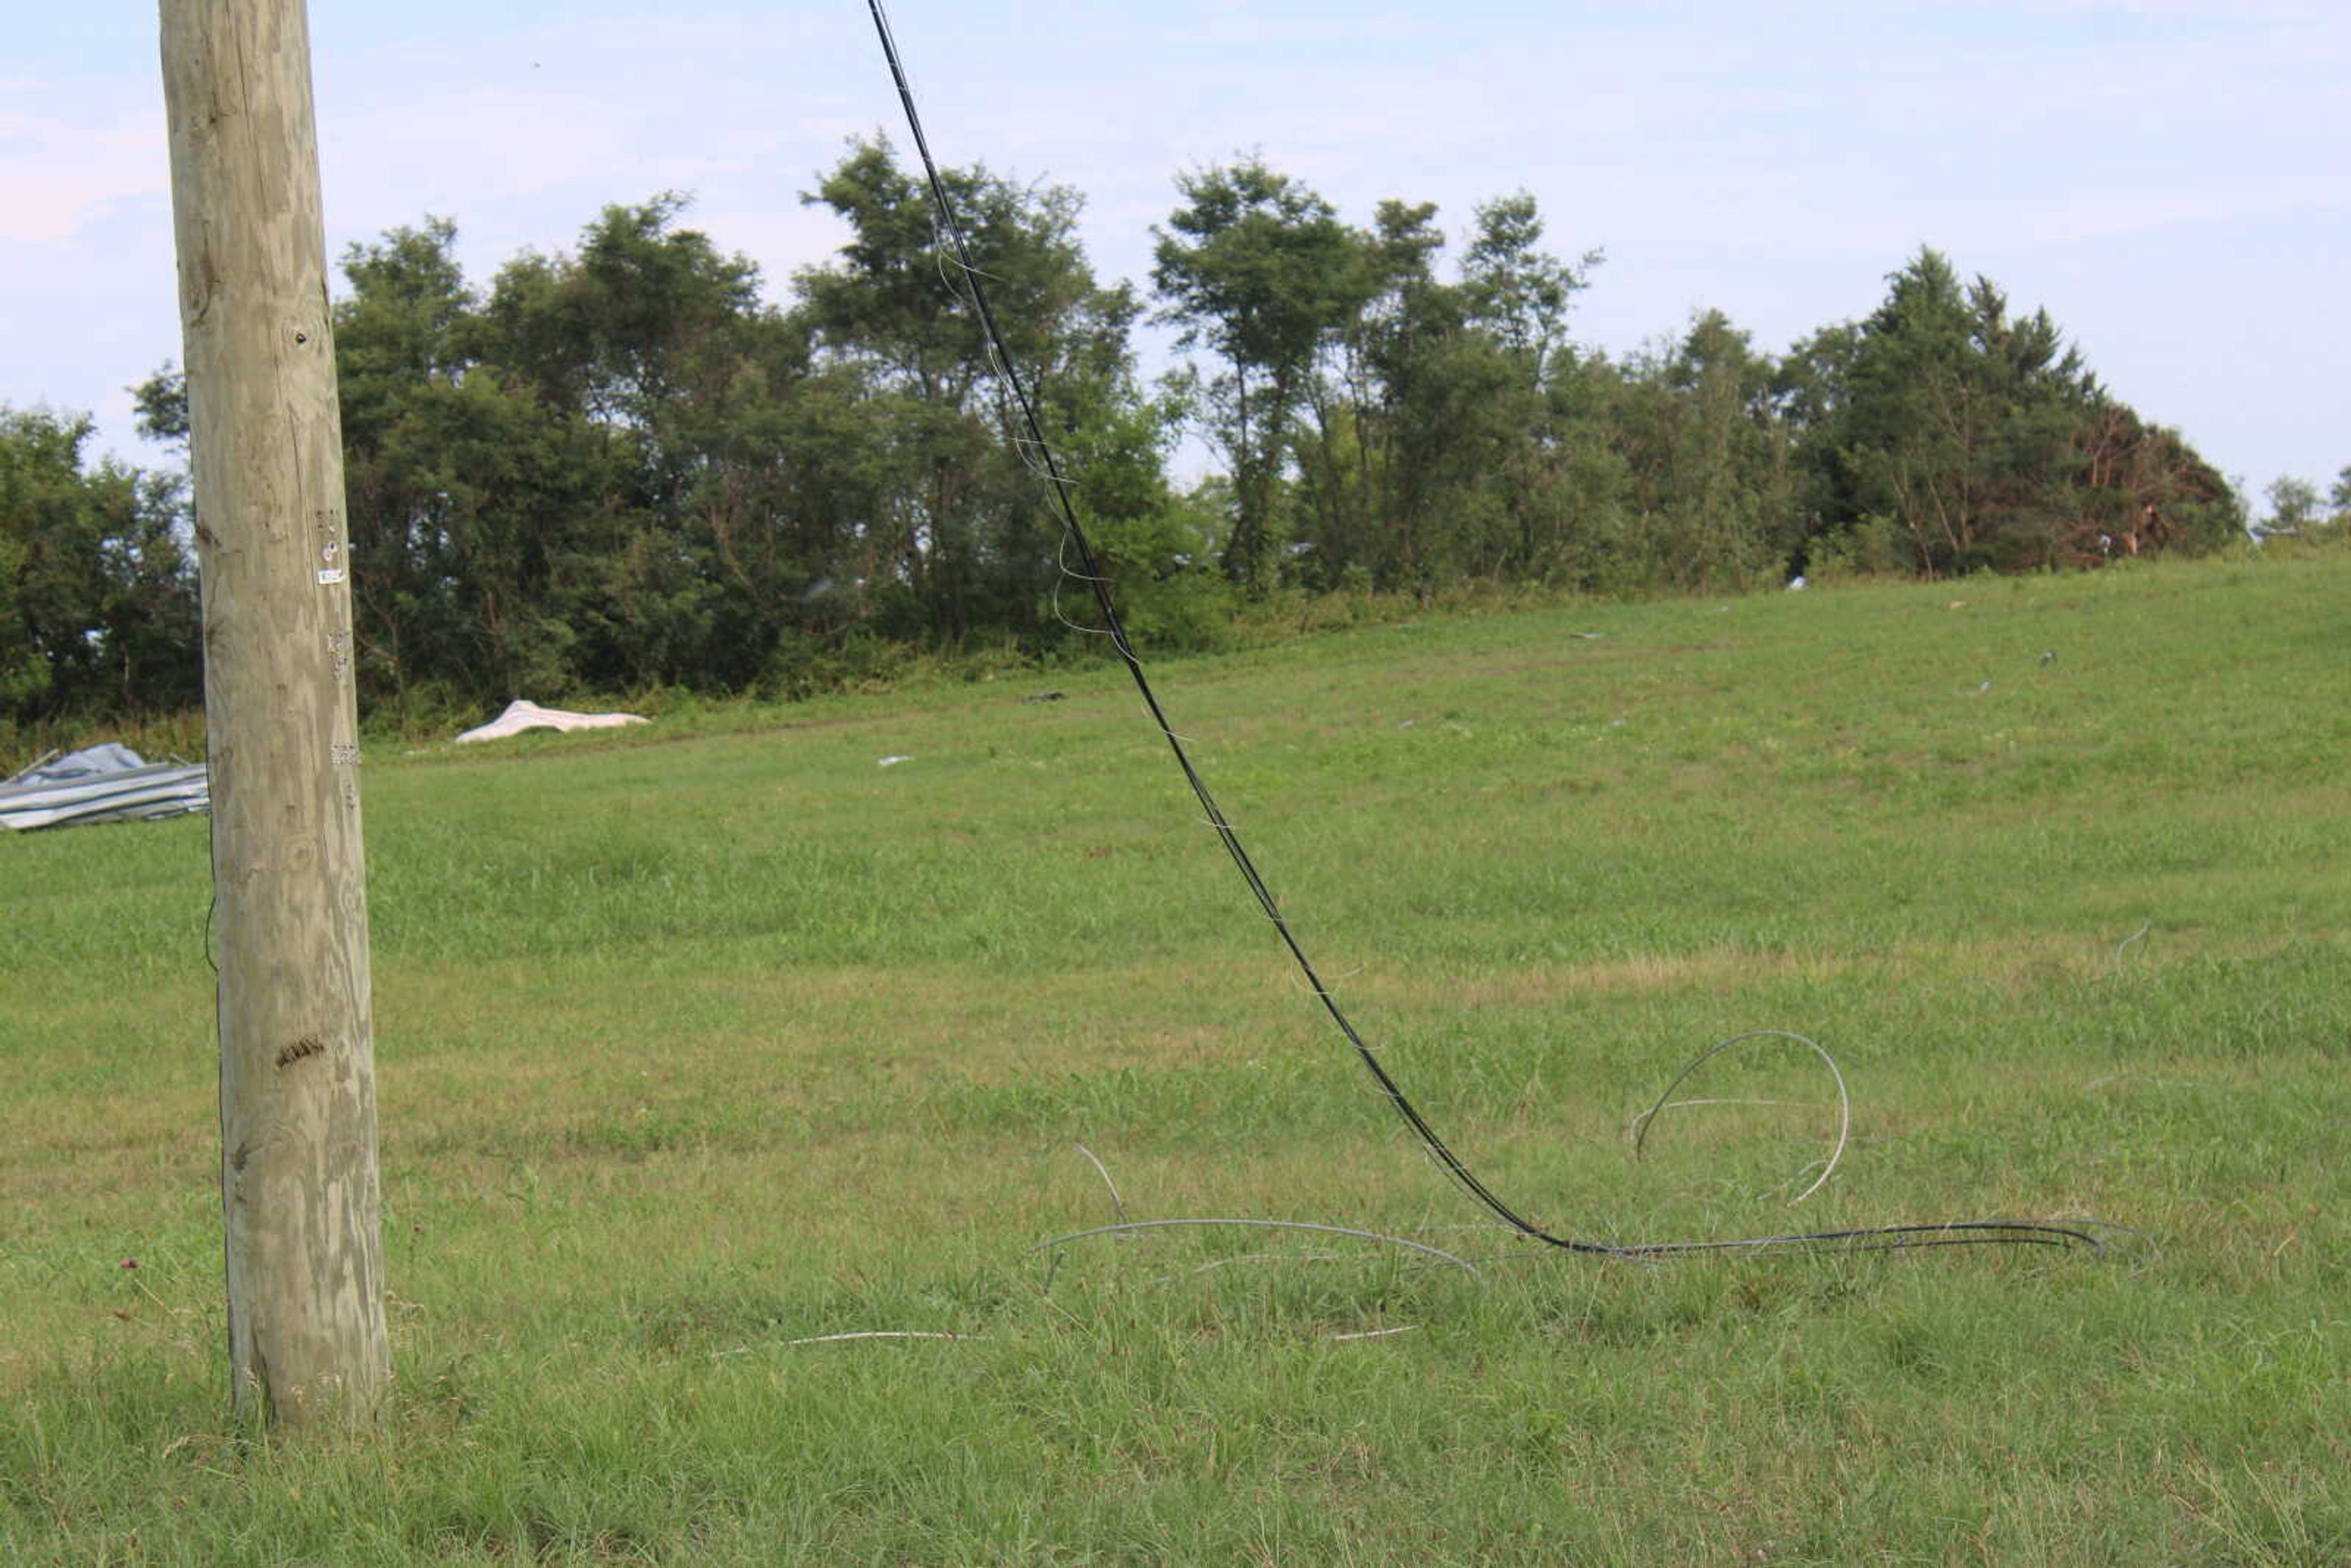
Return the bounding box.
[0,0,2351,503]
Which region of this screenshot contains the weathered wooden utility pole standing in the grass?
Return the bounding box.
[162,0,392,1425]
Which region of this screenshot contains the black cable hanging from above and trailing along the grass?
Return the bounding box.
[865,0,2102,1267]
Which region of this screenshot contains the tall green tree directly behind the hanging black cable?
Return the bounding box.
[792,139,1183,642]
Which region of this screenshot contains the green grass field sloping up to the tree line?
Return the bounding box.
[0,557,2351,1568]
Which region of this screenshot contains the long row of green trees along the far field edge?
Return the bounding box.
[0,139,2313,722]
